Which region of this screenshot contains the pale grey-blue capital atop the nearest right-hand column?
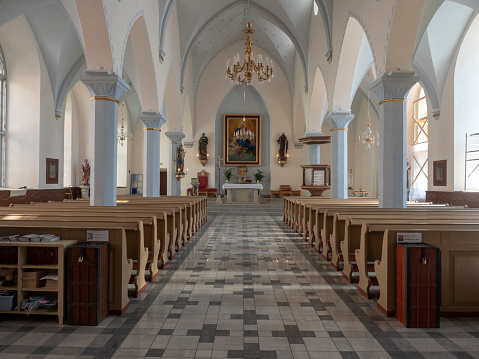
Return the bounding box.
[370,71,419,105]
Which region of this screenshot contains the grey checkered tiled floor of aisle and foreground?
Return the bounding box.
[0,201,479,358]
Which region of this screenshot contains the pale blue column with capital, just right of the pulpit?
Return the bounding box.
[326,112,354,199]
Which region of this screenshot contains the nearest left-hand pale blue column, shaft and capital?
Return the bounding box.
[81,70,130,206]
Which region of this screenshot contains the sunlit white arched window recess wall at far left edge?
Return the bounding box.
[0,16,40,188]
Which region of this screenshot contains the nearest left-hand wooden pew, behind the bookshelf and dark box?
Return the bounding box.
[0,219,133,315]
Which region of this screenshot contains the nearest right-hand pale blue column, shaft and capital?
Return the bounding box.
[371,71,419,208]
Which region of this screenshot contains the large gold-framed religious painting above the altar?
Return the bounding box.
[223,115,261,166]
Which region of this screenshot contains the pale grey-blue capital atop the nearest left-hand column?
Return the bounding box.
[80,70,130,103]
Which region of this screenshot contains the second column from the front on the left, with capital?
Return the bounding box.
[138,112,166,197]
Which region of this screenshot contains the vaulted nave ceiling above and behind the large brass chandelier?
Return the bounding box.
[177,0,313,89]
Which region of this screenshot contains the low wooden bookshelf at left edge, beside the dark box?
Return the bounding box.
[0,240,77,324]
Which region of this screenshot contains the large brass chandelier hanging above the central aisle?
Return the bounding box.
[225,22,274,85]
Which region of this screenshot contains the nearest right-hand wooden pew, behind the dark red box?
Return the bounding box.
[372,223,479,316]
